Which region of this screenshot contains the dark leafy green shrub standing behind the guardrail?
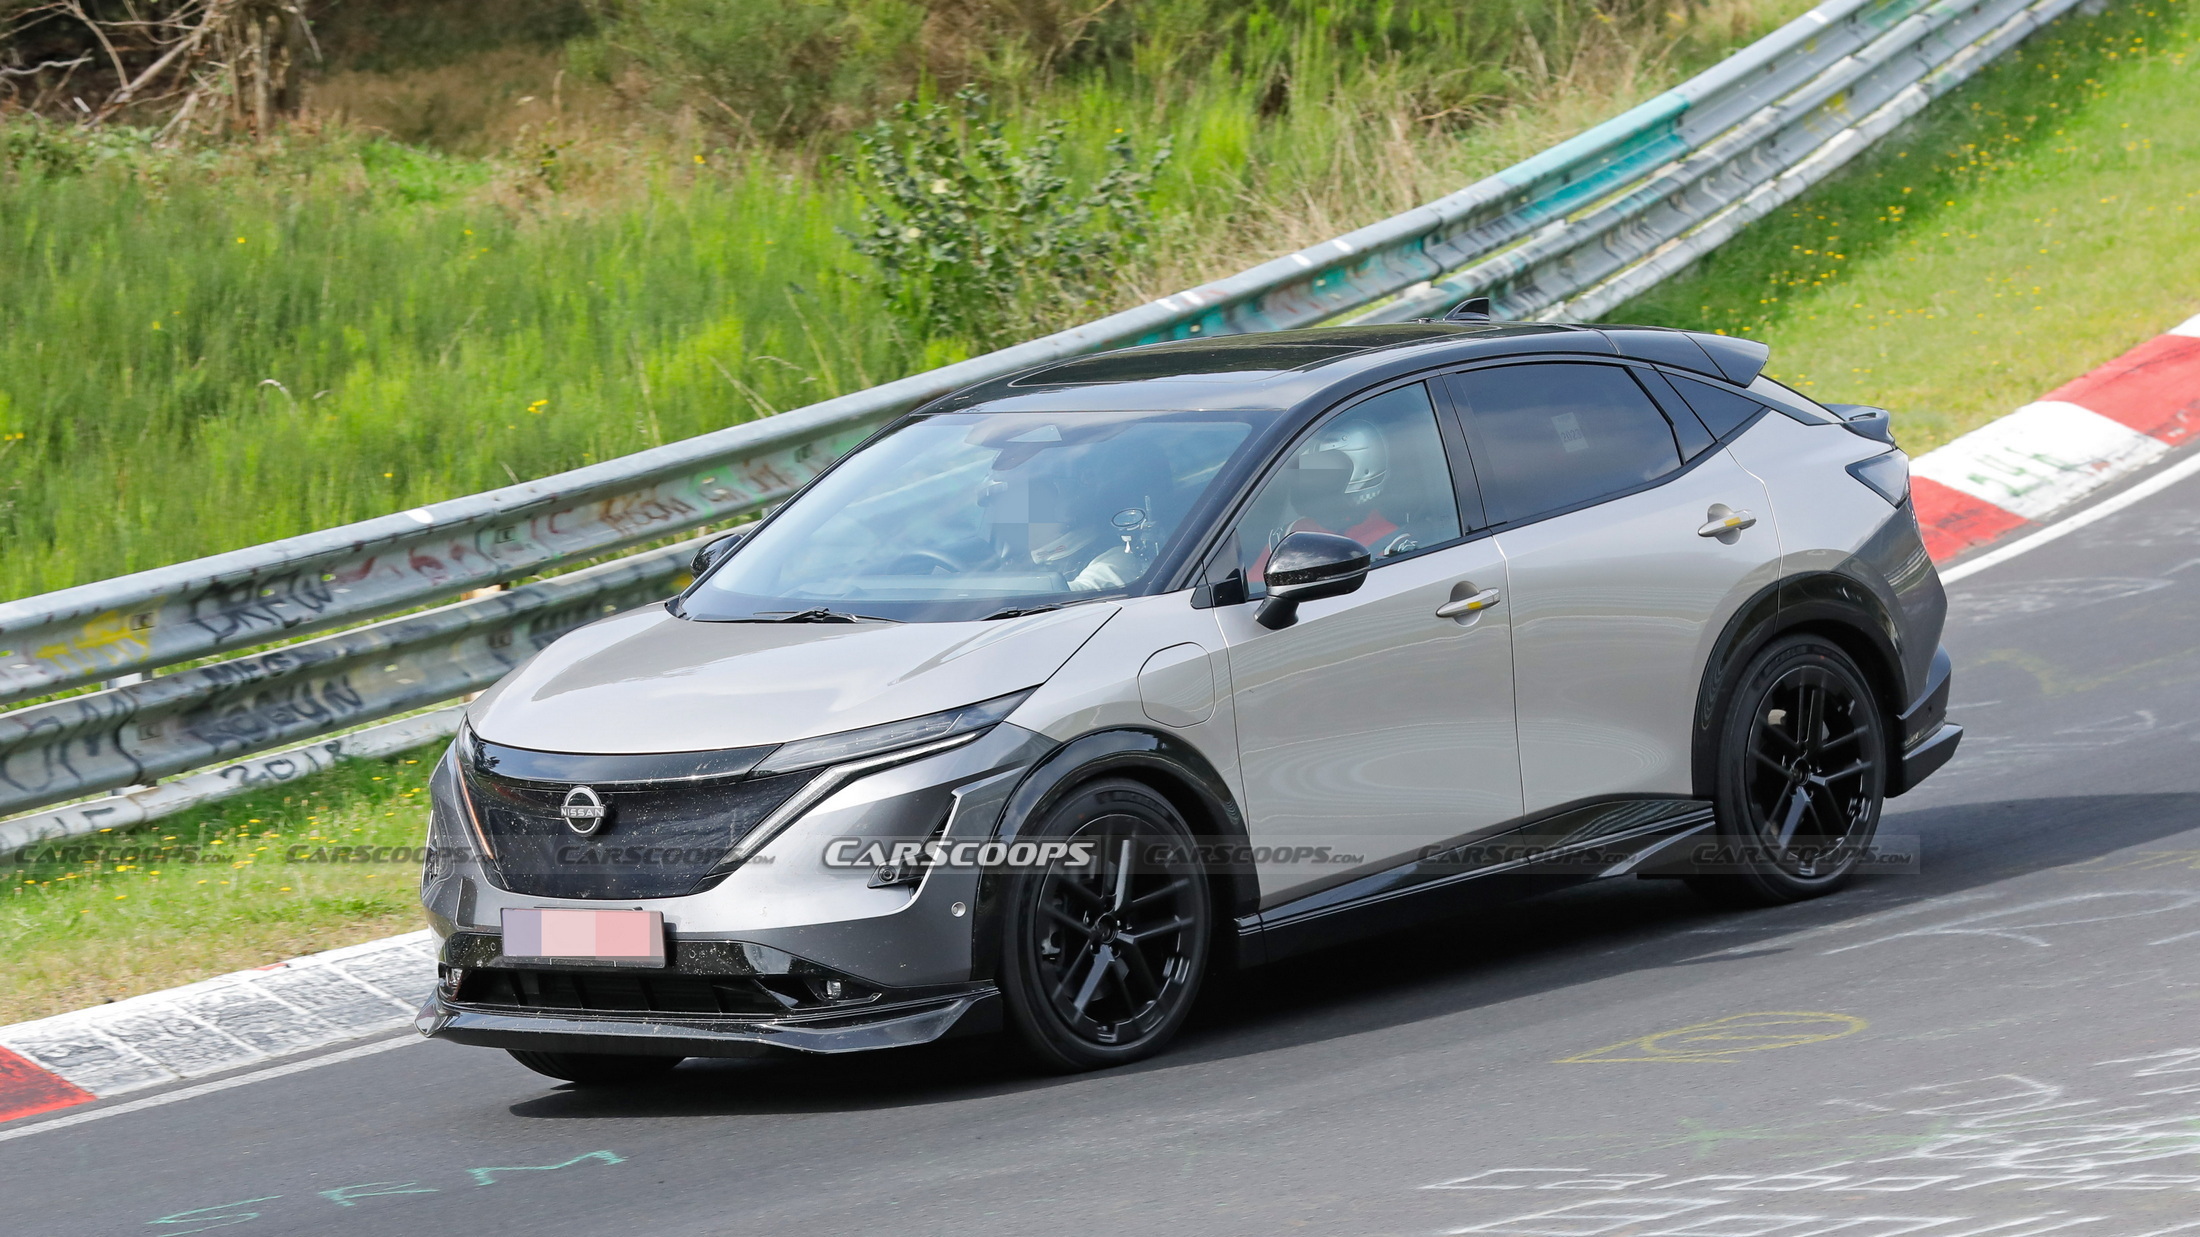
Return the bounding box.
[843,88,1170,348]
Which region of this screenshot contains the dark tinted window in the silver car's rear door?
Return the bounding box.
[1452,363,1681,522]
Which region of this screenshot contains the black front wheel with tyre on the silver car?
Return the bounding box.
[1001,779,1212,1070]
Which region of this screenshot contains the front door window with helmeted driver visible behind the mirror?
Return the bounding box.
[1236,383,1459,596]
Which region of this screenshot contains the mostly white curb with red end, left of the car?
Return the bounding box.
[0,931,436,1120]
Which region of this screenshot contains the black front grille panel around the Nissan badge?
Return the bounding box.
[466,768,816,900]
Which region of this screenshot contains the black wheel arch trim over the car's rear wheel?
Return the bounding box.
[1692,572,1905,797]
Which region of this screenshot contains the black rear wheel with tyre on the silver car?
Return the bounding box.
[1690,636,1888,907]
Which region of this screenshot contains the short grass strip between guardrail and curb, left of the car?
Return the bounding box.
[0,746,442,1026]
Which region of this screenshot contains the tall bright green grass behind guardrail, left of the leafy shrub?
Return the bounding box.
[0,141,904,596]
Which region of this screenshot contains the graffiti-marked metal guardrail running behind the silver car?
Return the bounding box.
[0,0,2077,832]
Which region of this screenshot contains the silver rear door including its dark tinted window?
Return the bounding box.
[1450,361,1780,814]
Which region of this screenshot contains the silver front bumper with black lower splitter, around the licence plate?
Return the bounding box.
[416,724,1052,1057]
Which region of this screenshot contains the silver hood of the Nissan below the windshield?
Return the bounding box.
[466,603,1118,753]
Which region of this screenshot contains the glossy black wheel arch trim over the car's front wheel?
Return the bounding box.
[970,729,1261,977]
